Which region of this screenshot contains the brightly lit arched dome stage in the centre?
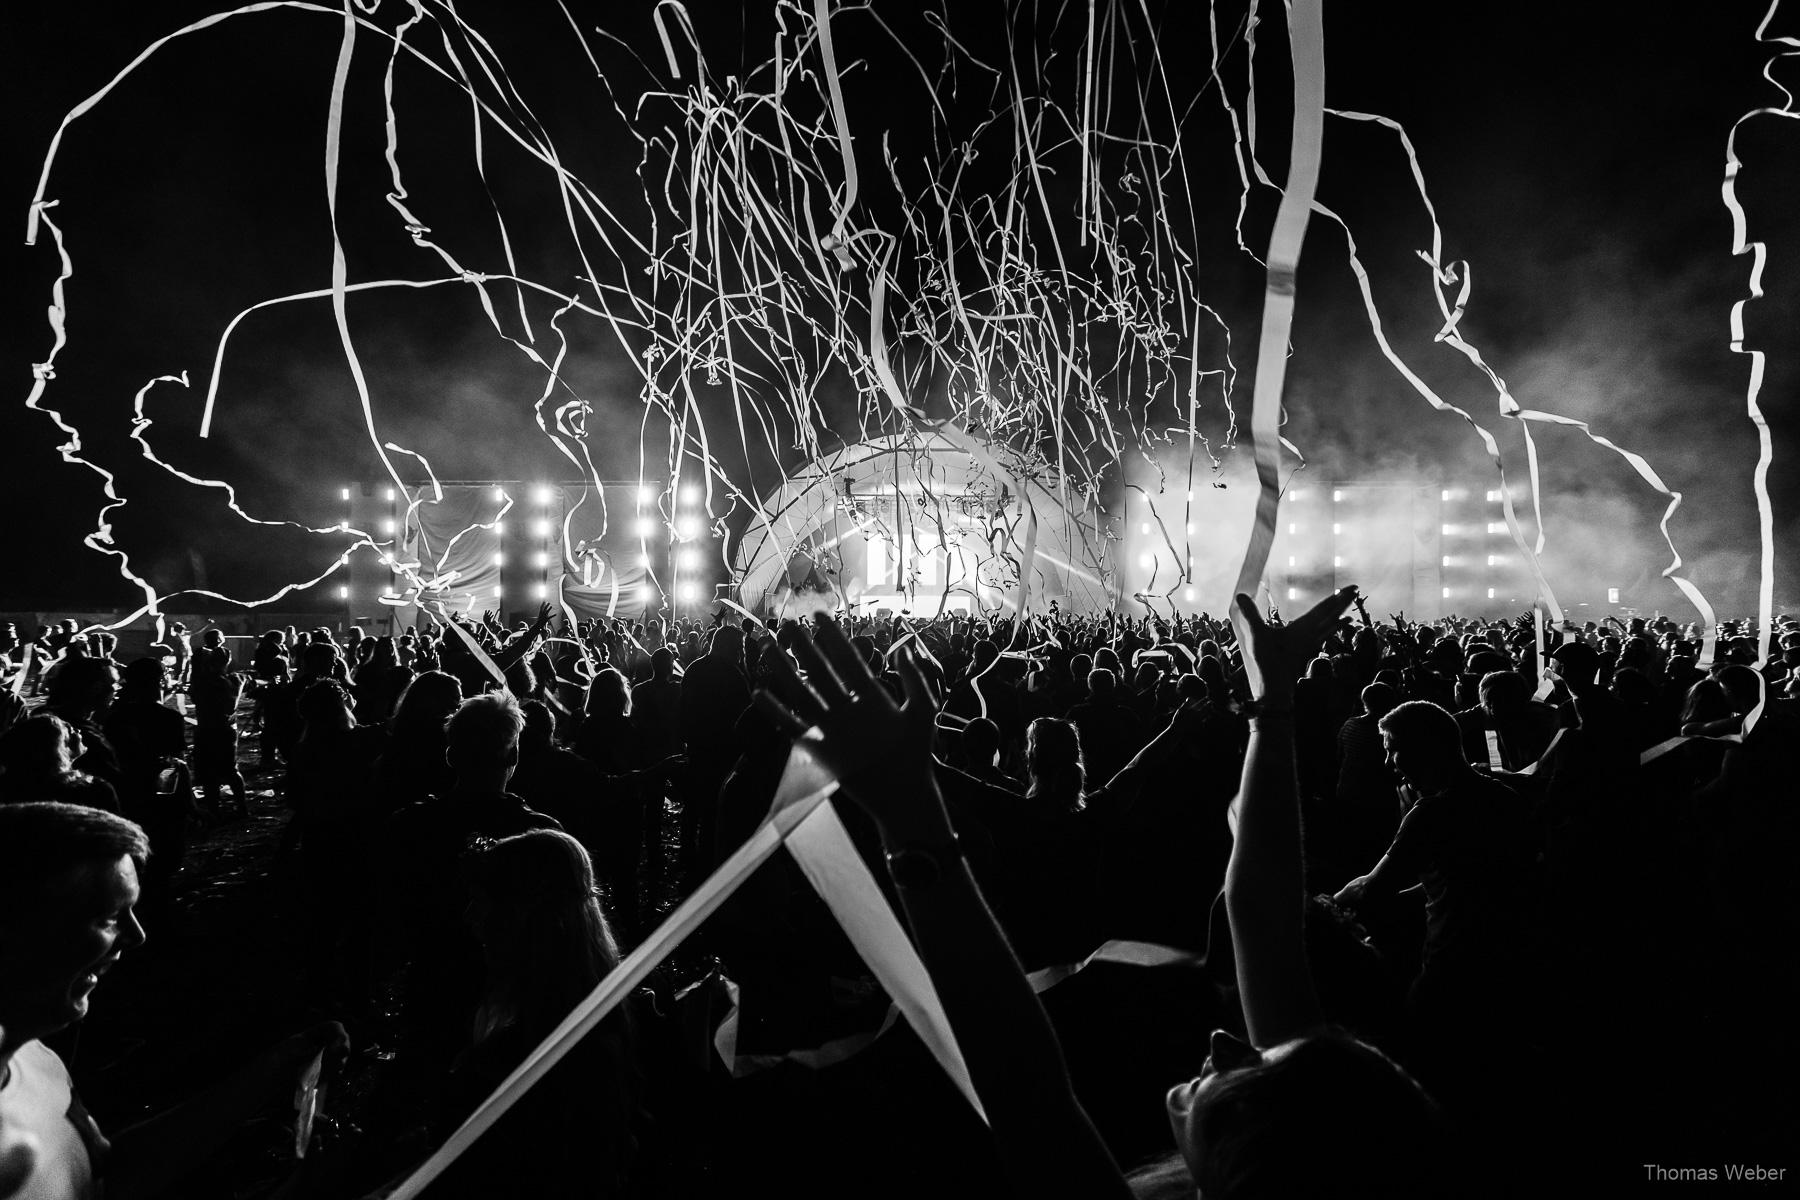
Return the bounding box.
[733,434,1114,617]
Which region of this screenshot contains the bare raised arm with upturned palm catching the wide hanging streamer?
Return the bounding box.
[1226,588,1355,1049]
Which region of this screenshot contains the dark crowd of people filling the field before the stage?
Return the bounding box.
[0,588,1800,1200]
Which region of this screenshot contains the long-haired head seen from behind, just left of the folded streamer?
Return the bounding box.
[463,834,619,1042]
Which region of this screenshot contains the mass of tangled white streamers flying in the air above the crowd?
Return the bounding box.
[17,0,1771,649]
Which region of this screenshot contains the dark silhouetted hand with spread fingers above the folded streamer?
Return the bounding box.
[756,615,938,822]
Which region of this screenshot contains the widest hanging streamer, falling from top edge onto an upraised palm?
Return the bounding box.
[1231,0,1325,693]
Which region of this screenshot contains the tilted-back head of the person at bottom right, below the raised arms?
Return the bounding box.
[1166,1027,1444,1200]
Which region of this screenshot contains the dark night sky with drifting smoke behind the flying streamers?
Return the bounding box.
[0,0,1800,619]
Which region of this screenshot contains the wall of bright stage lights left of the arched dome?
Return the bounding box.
[338,480,722,624]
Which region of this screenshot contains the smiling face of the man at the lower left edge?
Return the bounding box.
[0,855,144,1040]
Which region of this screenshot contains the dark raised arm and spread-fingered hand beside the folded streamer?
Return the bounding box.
[756,619,1130,1198]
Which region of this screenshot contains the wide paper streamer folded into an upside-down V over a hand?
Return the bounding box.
[391,734,981,1200]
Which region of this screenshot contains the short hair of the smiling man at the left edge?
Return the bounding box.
[0,801,149,923]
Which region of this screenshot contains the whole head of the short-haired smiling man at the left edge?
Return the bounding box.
[0,804,149,1049]
